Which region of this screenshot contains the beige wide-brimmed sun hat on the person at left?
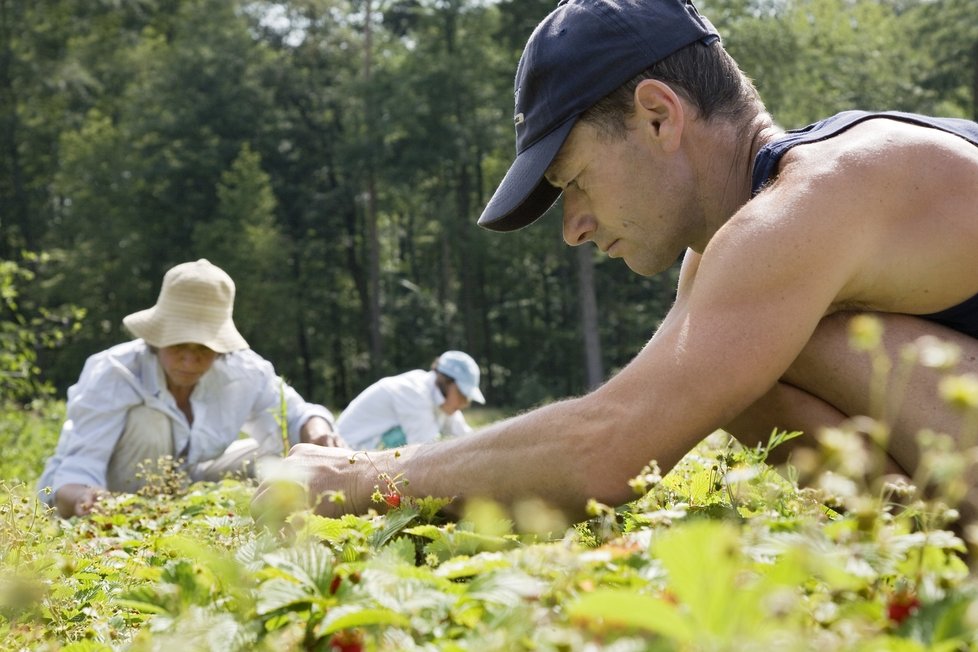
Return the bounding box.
[122,258,248,353]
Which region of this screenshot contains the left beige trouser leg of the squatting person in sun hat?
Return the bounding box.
[106,405,173,493]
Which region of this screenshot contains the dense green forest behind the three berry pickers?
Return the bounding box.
[0,0,978,409]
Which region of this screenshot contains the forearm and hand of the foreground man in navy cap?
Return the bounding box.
[264,342,724,519]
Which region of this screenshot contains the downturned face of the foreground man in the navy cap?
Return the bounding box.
[545,121,695,276]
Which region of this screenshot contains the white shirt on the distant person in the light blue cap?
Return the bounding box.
[336,369,472,449]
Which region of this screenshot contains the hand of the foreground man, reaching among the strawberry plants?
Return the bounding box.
[251,444,377,527]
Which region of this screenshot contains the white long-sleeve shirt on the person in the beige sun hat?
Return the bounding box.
[37,339,333,499]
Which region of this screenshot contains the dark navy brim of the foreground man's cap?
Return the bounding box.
[479,116,577,231]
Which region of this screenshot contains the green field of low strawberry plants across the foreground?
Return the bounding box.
[0,403,978,652]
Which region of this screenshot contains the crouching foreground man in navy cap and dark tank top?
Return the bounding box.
[255,0,978,522]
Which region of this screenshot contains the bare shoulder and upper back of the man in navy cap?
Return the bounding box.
[704,120,978,314]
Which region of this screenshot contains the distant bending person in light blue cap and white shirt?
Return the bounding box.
[336,351,486,449]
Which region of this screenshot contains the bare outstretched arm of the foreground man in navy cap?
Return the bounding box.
[254,143,900,516]
